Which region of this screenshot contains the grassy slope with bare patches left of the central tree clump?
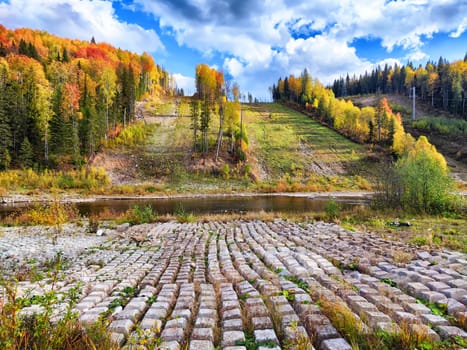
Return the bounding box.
[130,99,252,192]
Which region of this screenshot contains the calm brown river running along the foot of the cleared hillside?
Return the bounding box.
[0,195,368,218]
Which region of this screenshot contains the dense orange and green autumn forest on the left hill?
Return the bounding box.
[0,25,173,169]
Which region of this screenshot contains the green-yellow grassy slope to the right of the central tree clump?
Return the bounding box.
[245,104,372,179]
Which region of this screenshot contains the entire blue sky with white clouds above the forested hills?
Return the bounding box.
[0,0,467,100]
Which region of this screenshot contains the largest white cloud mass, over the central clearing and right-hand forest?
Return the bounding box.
[134,0,467,94]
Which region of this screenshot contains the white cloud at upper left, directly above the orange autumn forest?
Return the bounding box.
[0,0,164,53]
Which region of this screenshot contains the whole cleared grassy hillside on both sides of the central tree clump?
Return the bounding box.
[92,98,376,191]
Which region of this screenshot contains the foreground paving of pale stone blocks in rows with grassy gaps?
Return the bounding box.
[0,219,467,350]
